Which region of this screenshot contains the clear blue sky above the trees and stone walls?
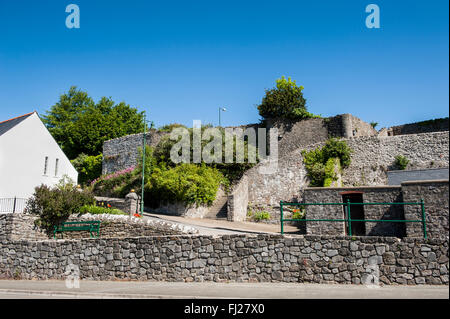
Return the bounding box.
[0,0,449,128]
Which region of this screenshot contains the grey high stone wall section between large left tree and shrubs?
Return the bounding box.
[102,130,167,174]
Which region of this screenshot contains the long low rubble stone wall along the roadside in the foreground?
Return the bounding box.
[0,235,449,285]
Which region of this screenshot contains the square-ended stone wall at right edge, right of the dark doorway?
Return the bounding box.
[402,180,449,238]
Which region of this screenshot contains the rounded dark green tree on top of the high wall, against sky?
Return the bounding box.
[258,76,315,120]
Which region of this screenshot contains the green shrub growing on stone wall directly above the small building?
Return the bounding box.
[302,138,352,187]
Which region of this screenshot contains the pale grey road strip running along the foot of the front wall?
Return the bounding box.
[0,280,449,299]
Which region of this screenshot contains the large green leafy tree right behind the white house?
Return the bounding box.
[42,86,148,159]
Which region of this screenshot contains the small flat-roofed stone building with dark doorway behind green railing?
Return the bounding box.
[303,179,449,238]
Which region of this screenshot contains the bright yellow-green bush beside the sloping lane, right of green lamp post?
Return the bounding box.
[144,164,227,206]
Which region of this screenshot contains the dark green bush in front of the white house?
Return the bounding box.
[25,181,95,236]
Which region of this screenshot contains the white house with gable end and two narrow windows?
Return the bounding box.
[0,112,78,202]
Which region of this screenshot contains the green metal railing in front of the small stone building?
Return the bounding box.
[280,199,427,238]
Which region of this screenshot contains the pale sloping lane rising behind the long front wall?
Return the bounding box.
[143,212,299,235]
